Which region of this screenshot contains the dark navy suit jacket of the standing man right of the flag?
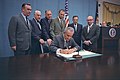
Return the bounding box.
[68,23,82,46]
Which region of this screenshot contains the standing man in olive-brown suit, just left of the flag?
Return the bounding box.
[50,9,65,37]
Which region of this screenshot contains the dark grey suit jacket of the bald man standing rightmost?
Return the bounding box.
[82,24,100,51]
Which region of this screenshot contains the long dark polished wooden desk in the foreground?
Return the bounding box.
[0,54,120,80]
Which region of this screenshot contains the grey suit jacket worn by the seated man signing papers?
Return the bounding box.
[50,34,80,53]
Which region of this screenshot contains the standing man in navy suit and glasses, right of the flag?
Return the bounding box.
[68,16,82,47]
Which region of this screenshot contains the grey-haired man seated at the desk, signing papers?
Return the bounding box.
[50,27,80,54]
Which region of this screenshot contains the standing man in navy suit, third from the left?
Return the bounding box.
[41,10,52,45]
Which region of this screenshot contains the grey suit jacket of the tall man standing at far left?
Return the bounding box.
[8,14,32,51]
